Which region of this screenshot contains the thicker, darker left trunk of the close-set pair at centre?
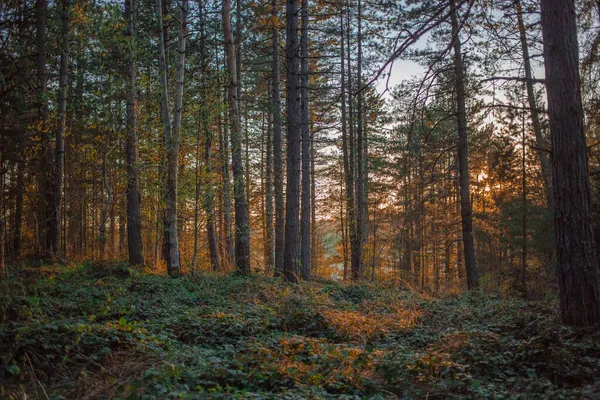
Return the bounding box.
[283,0,301,282]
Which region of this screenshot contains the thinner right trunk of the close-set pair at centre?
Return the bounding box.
[300,0,311,279]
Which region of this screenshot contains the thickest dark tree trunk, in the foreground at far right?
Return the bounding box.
[541,0,600,326]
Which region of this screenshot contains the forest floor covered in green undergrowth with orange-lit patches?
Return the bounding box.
[0,265,600,399]
